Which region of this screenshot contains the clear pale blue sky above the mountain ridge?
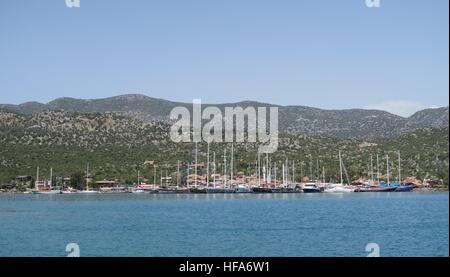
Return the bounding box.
[0,0,449,115]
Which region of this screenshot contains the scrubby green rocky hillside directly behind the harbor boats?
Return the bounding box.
[0,111,449,183]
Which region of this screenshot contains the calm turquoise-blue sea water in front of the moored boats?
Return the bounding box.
[0,192,449,256]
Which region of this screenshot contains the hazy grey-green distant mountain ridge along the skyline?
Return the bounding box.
[0,94,449,138]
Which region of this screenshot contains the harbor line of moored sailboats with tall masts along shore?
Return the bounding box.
[3,143,448,194]
